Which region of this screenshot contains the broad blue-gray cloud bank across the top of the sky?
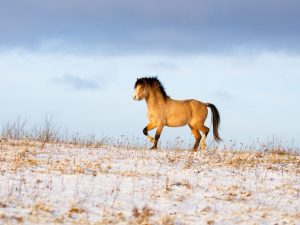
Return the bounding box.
[0,0,300,53]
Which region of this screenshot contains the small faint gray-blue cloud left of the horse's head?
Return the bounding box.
[52,74,100,90]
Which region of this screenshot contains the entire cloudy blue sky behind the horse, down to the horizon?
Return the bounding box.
[0,0,300,146]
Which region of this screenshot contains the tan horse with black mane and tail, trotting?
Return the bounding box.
[133,77,222,151]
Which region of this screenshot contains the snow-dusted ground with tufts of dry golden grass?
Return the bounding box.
[0,140,300,225]
